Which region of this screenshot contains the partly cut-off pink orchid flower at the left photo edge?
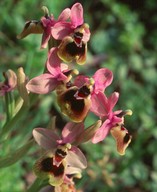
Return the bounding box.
[0,69,17,96]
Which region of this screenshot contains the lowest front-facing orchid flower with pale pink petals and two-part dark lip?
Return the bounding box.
[33,122,87,186]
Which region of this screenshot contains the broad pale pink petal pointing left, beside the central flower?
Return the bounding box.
[26,73,58,94]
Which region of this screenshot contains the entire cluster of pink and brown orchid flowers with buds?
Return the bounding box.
[0,3,132,192]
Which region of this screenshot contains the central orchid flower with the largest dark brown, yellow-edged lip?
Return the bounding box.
[56,68,113,122]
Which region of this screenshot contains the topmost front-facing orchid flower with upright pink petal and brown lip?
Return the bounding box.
[52,3,90,64]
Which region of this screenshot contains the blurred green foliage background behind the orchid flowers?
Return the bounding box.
[0,0,157,192]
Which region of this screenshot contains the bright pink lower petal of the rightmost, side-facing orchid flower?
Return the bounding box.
[92,119,111,143]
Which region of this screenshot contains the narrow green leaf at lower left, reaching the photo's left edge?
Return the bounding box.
[0,140,34,168]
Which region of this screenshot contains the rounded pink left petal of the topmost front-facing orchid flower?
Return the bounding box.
[51,22,73,40]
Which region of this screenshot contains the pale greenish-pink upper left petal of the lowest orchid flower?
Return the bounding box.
[33,128,59,150]
